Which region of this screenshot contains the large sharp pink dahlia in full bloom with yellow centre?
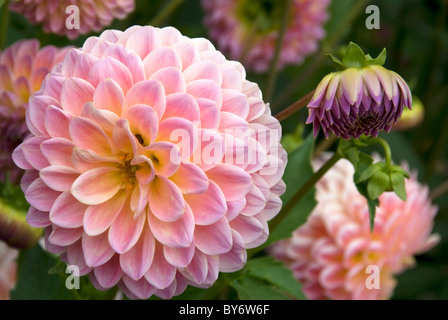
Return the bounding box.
[13,26,286,298]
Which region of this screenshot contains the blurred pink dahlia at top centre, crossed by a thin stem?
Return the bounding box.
[202,0,330,72]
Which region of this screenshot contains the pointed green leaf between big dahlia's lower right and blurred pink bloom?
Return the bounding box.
[247,257,306,300]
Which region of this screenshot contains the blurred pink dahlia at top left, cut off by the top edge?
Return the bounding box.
[9,0,135,39]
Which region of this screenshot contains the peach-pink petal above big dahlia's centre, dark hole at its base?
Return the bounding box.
[126,104,159,146]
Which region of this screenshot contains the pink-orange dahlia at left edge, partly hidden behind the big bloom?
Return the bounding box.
[0,39,68,182]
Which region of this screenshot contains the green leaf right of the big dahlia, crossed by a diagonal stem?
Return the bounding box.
[265,134,316,245]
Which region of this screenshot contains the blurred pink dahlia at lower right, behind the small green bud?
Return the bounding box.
[271,160,438,300]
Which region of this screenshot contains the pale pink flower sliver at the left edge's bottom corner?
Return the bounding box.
[0,241,19,300]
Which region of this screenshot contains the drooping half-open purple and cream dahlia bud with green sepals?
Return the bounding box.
[307,43,412,140]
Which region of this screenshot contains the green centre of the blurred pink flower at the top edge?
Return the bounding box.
[236,0,292,35]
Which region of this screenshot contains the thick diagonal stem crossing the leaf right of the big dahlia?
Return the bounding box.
[269,152,342,233]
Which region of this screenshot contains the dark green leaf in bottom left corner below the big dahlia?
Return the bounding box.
[11,245,75,300]
